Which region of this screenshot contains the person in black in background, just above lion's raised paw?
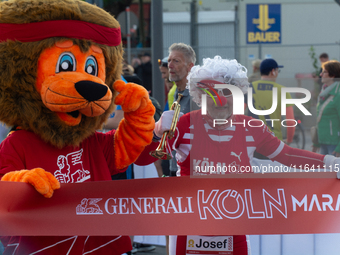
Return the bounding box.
[134,52,152,95]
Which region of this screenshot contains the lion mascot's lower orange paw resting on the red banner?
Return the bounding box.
[1,168,60,198]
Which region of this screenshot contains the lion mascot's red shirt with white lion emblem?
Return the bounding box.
[0,130,131,255]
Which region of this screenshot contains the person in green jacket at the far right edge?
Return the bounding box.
[312,60,340,157]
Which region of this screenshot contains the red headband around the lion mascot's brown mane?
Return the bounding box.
[0,20,121,46]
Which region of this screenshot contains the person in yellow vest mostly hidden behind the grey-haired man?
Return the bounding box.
[158,57,177,111]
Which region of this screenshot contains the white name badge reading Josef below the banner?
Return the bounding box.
[186,236,233,255]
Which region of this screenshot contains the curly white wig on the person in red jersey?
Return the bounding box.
[187,56,249,106]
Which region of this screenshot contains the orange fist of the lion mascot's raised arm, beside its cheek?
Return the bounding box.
[113,80,149,112]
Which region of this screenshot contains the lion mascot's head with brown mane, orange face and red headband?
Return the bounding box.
[0,0,123,148]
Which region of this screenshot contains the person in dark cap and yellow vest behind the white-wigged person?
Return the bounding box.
[248,58,295,158]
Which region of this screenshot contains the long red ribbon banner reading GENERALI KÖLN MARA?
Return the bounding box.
[0,173,340,236]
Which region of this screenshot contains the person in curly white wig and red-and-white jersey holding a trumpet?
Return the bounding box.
[135,56,340,255]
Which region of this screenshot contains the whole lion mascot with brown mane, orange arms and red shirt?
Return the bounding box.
[0,0,155,255]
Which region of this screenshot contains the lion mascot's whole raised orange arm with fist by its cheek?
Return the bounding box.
[113,80,155,169]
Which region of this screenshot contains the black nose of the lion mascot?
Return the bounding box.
[75,81,108,102]
